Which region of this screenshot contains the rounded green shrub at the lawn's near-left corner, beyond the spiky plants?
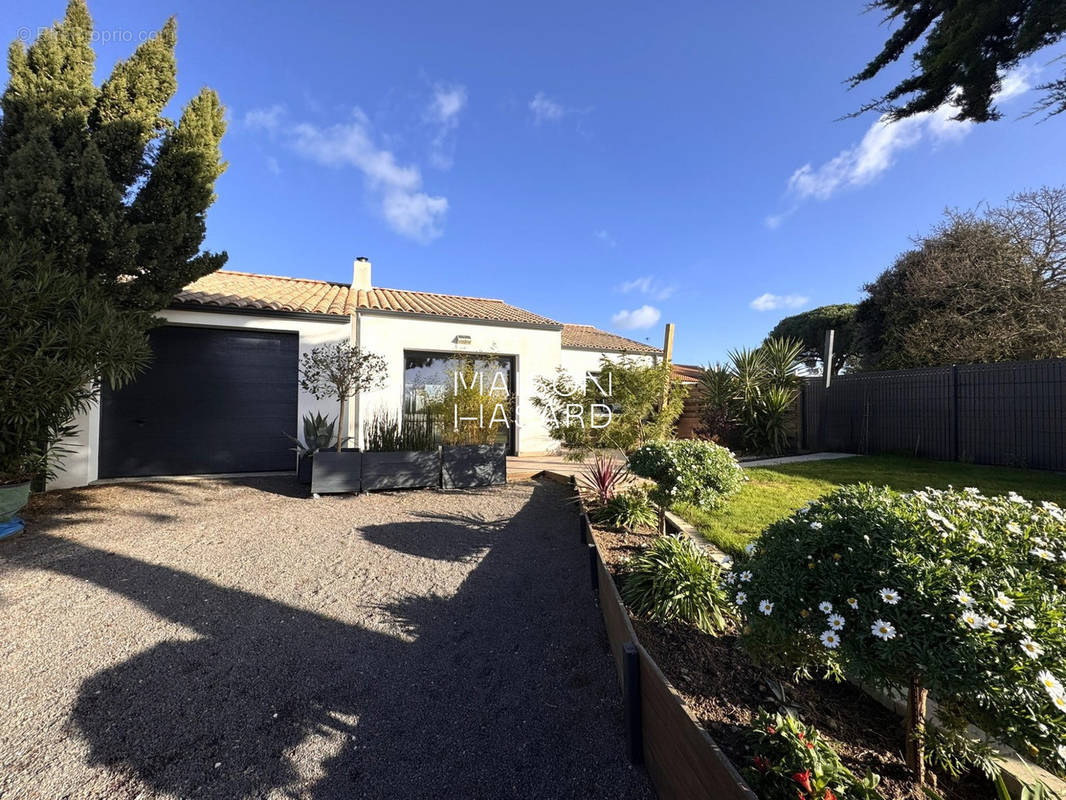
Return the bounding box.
[629,439,744,509]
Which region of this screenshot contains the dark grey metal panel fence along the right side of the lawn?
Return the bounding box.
[801,358,1066,469]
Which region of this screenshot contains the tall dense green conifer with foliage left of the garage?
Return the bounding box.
[0,0,226,485]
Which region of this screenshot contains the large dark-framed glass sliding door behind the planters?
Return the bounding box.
[403,350,518,454]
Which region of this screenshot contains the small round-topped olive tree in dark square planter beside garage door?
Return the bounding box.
[300,342,387,494]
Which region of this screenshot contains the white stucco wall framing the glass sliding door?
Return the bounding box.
[356,311,562,455]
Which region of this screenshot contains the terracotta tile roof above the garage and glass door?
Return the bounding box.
[174,270,559,327]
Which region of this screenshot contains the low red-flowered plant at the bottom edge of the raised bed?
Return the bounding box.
[743,710,882,800]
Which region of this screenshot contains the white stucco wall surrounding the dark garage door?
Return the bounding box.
[48,310,351,489]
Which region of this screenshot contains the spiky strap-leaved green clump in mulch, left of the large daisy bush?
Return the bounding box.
[621,537,732,634]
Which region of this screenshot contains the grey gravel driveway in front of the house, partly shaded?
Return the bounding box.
[0,478,650,800]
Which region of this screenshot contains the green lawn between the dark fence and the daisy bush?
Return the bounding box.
[674,455,1066,555]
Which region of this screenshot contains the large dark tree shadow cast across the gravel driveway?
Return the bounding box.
[23,485,650,799]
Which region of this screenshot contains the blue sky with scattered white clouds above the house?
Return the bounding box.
[8,0,1066,364]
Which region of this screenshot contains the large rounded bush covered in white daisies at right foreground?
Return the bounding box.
[726,485,1066,774]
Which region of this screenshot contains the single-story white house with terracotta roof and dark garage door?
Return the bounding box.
[56,258,662,489]
